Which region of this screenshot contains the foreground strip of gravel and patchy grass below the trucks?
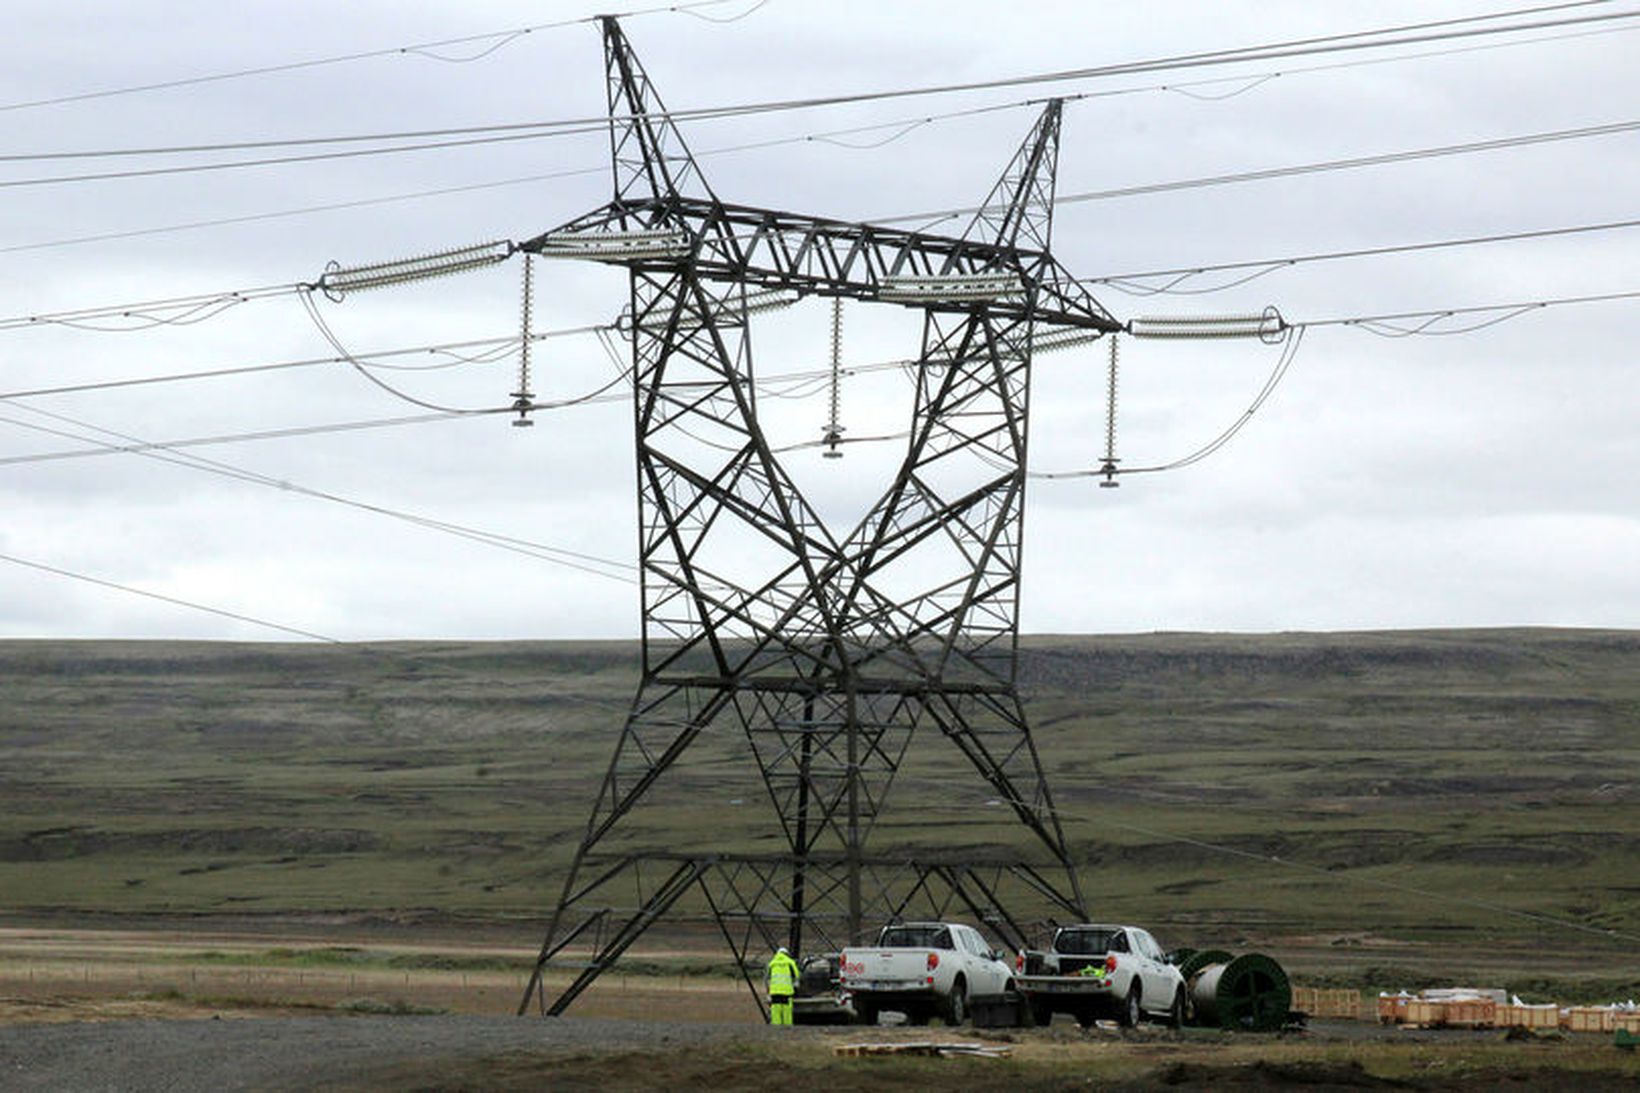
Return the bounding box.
[0,1016,1640,1093]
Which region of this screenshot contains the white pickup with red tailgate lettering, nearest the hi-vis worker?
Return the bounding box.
[838,922,1014,1026]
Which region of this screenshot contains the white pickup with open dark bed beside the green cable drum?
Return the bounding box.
[1014,922,1186,1027]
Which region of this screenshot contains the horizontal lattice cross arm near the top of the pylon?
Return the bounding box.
[520,195,1122,333]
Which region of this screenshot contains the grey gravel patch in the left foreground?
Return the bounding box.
[0,1016,812,1093]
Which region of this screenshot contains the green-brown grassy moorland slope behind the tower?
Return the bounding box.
[0,630,1640,975]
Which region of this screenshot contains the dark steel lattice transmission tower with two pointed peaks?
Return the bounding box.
[520,18,1118,1013]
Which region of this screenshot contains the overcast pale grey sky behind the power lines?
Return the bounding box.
[0,0,1640,640]
